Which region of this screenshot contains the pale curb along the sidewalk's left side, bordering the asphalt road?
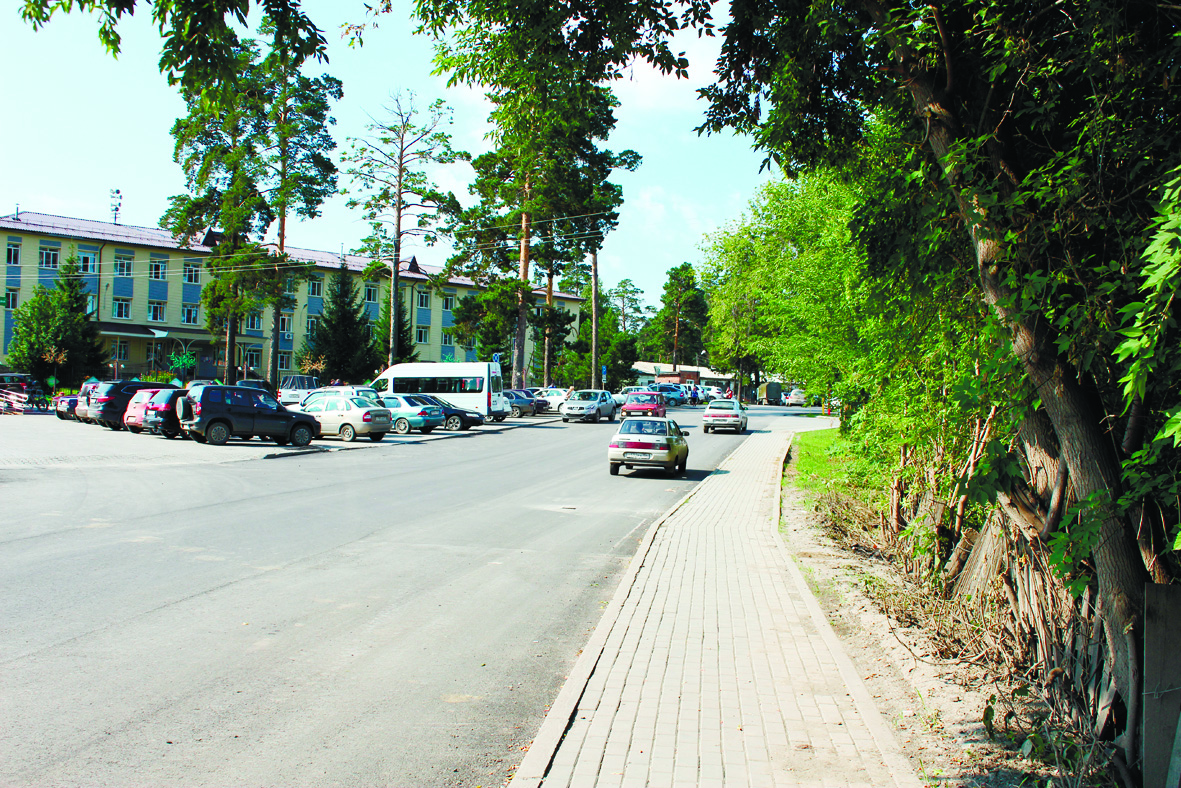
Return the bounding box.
[507,441,746,788]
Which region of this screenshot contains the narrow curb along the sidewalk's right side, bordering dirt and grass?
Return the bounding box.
[775,432,922,788]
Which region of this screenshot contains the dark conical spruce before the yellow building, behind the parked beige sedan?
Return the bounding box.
[299,266,383,383]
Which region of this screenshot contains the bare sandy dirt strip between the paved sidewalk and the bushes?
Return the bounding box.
[781,482,1048,788]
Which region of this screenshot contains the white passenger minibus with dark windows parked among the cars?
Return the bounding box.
[370,362,509,421]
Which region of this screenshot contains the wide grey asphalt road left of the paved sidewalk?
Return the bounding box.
[0,408,831,787]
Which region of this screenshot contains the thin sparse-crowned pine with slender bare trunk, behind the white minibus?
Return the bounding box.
[342,92,470,365]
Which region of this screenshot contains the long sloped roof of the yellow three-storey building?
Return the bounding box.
[0,210,582,301]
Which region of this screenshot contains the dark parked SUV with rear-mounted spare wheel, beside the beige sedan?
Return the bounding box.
[176,385,320,447]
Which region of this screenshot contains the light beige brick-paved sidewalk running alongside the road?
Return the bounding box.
[510,432,920,788]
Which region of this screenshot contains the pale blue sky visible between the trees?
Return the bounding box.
[0,0,769,304]
